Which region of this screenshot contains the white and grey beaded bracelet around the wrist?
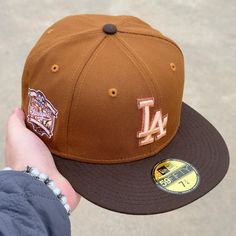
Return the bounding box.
[2,165,71,215]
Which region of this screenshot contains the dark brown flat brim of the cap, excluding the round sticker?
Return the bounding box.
[53,103,229,215]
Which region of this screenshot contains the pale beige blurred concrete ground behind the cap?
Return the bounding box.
[0,0,236,236]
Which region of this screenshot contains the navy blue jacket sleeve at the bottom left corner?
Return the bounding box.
[0,170,71,236]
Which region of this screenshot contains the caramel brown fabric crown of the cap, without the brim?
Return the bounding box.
[22,14,184,163]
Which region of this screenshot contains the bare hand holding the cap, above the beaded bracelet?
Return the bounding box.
[5,108,80,211]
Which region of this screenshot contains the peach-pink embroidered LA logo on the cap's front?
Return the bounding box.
[137,98,168,146]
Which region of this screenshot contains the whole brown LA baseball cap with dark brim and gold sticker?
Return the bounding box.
[22,14,229,215]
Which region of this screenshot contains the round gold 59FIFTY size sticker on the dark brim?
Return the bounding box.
[152,159,200,194]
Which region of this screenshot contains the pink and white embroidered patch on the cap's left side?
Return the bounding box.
[27,88,58,138]
